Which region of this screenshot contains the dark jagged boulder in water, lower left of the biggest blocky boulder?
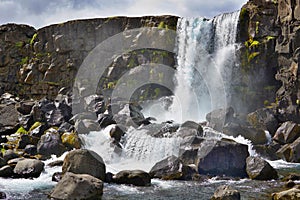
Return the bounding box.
[149,156,197,180]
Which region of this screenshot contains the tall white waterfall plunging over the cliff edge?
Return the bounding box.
[165,12,239,122]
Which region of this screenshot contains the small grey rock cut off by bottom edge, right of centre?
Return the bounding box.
[211,185,241,200]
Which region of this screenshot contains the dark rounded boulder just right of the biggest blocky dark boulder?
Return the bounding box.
[246,156,278,180]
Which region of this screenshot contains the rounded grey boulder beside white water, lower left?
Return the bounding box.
[14,159,45,178]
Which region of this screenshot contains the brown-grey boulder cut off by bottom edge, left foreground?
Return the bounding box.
[50,172,103,200]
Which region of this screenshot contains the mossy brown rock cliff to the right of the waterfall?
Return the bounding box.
[238,0,300,122]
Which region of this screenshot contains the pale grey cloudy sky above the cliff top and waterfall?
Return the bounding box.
[0,0,247,28]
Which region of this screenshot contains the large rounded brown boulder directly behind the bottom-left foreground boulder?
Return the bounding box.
[62,149,106,181]
